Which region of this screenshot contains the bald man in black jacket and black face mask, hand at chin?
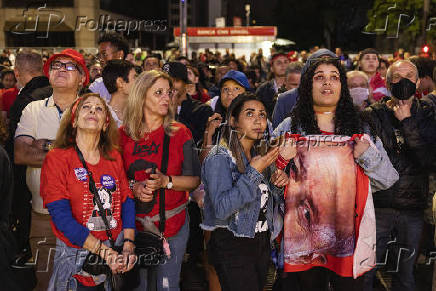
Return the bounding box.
[363,60,434,291]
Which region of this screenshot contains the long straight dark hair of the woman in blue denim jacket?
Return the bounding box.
[220,92,268,173]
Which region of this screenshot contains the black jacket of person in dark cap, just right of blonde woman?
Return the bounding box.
[176,95,213,145]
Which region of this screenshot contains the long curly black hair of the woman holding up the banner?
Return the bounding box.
[290,58,363,136]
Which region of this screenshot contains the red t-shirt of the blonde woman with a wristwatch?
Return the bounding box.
[120,122,198,237]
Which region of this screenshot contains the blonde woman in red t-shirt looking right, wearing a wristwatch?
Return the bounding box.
[120,70,200,290]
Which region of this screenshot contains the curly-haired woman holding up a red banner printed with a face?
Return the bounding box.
[274,58,398,291]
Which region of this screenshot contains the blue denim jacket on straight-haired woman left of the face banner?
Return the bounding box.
[201,145,283,240]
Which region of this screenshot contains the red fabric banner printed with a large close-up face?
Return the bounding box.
[283,135,375,277]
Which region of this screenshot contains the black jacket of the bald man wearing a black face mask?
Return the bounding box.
[363,98,434,210]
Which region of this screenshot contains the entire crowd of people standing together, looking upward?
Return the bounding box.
[0,33,436,291]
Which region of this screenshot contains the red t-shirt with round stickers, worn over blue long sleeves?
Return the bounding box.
[41,148,133,248]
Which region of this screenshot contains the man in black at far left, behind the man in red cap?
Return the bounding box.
[5,52,52,265]
